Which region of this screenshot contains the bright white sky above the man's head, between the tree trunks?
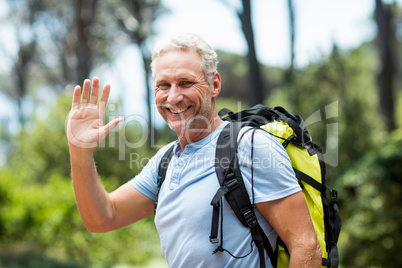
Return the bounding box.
[156,0,376,66]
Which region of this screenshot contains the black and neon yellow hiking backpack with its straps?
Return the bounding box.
[155,104,341,267]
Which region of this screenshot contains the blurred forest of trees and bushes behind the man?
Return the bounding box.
[0,0,402,267]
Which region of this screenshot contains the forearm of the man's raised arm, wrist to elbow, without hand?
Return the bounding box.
[70,146,113,232]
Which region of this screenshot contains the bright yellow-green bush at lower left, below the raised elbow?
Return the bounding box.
[0,170,159,264]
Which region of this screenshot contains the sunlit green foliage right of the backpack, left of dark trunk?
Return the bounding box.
[266,44,385,182]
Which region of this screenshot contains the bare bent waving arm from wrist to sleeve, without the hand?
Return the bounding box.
[70,147,154,233]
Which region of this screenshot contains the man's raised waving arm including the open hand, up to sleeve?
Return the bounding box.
[67,78,154,232]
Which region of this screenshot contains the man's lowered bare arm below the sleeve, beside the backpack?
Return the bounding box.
[256,192,322,268]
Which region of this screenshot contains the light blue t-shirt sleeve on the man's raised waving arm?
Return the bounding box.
[128,143,173,200]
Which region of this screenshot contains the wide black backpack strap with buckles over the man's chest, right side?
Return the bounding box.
[210,122,276,267]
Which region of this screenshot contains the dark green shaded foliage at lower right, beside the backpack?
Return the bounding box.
[339,131,402,267]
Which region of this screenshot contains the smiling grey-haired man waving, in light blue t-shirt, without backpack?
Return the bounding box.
[67,34,321,267]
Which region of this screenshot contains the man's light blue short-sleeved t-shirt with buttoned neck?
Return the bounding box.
[130,122,301,268]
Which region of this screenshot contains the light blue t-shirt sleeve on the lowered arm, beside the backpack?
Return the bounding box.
[238,128,301,203]
